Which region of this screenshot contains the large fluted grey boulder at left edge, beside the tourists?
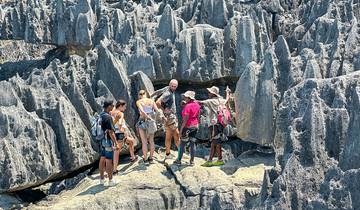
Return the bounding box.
[0,70,97,192]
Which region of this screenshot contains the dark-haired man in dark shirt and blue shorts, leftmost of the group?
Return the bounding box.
[99,100,119,186]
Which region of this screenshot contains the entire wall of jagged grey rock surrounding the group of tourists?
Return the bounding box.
[0,0,360,209]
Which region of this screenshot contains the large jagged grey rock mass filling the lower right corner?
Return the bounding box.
[258,72,360,209]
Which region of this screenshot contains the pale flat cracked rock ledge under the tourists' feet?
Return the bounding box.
[23,150,273,209]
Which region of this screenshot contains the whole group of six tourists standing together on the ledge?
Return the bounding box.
[93,79,231,186]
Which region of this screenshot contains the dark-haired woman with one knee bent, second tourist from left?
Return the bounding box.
[110,100,137,174]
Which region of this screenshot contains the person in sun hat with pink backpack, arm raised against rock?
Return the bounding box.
[198,86,229,167]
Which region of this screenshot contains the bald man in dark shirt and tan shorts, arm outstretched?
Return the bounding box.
[156,79,180,159]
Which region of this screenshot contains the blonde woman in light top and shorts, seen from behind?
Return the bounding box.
[136,90,158,163]
